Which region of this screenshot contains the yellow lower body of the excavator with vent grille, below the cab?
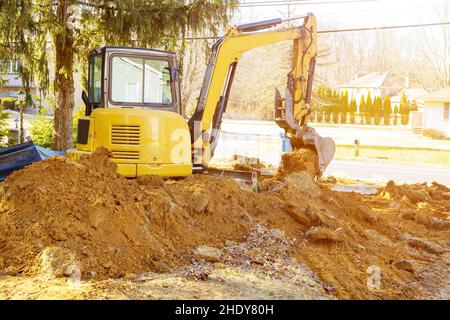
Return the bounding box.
[67,108,192,178]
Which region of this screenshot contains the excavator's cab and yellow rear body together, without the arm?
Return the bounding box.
[68,47,192,177]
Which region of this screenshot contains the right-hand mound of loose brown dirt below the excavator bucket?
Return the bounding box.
[249,175,450,299]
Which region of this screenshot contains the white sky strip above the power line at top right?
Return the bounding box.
[233,0,450,30]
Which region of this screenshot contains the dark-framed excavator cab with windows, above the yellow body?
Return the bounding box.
[85,47,181,115]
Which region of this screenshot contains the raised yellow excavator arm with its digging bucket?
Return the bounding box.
[188,14,334,175]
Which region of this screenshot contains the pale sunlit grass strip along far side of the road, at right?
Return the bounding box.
[334,145,450,167]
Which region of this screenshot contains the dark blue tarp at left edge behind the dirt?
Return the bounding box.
[0,141,66,180]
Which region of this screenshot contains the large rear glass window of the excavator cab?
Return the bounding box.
[111,56,172,105]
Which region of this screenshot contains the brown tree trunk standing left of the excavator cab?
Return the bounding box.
[53,0,75,151]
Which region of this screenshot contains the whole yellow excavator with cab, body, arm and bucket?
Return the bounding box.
[68,14,335,177]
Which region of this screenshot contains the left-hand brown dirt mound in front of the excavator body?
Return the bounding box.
[0,149,247,278]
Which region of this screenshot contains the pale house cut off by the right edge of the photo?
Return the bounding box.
[422,88,450,137]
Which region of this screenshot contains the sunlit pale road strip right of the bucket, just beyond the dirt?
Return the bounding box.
[325,160,450,187]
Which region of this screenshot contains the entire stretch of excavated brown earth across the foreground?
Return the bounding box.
[0,149,450,299]
